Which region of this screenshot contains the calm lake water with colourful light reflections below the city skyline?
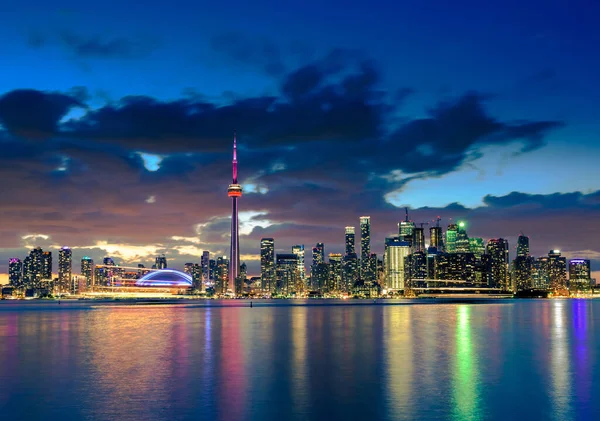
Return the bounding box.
[0,300,600,421]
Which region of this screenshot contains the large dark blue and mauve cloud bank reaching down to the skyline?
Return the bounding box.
[0,51,580,271]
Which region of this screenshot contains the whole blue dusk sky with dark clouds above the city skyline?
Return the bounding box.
[0,0,600,282]
